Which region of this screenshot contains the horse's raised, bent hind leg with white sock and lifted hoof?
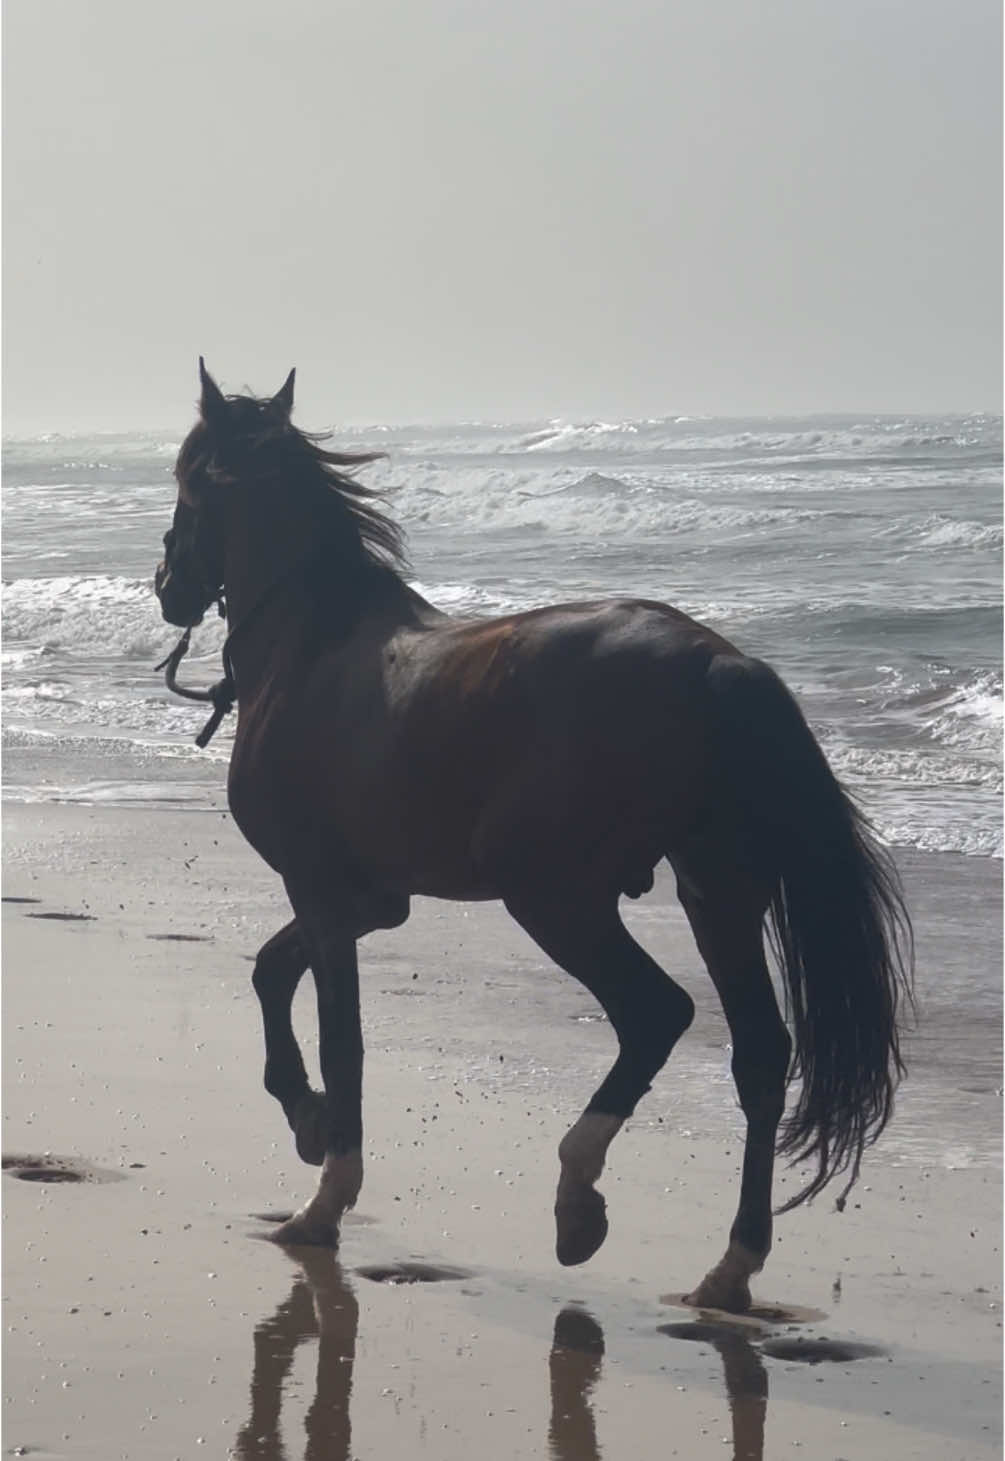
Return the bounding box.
[505,894,694,1264]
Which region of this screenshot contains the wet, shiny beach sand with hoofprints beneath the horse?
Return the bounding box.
[3,805,1002,1461]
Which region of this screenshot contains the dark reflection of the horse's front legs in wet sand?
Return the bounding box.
[234,1248,359,1461]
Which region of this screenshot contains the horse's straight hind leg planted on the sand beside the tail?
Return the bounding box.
[679,880,792,1313]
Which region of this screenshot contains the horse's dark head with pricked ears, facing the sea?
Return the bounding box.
[153,356,295,628]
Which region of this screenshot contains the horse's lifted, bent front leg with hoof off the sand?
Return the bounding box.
[251,919,326,1166]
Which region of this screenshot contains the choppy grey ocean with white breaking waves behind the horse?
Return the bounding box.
[3,415,1002,858]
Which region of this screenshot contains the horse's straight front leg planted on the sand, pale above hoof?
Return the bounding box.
[273,888,362,1248]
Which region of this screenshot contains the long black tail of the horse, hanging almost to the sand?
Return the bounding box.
[708,656,913,1211]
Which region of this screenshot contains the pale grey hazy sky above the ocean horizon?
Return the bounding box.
[3,0,1002,434]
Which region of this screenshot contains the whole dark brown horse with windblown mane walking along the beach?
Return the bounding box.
[156,361,910,1311]
